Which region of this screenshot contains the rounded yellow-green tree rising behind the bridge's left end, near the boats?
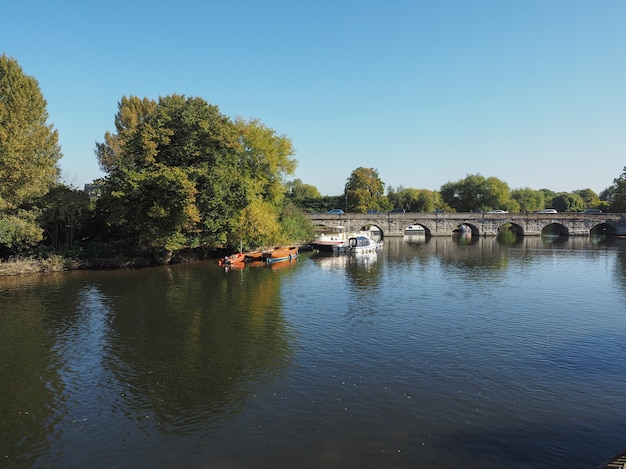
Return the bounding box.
[344,167,385,213]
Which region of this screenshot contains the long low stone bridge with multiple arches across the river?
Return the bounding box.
[308,212,621,237]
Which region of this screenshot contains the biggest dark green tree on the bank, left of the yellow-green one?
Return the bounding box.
[96,95,241,259]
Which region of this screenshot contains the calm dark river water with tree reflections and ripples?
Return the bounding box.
[0,238,626,469]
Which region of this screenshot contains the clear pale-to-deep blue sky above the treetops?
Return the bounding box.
[0,0,626,195]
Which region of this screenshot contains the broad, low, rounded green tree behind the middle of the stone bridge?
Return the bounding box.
[440,174,510,212]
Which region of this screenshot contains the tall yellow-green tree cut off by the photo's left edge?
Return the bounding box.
[0,54,61,251]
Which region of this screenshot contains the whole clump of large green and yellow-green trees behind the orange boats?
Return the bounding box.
[96,95,295,252]
